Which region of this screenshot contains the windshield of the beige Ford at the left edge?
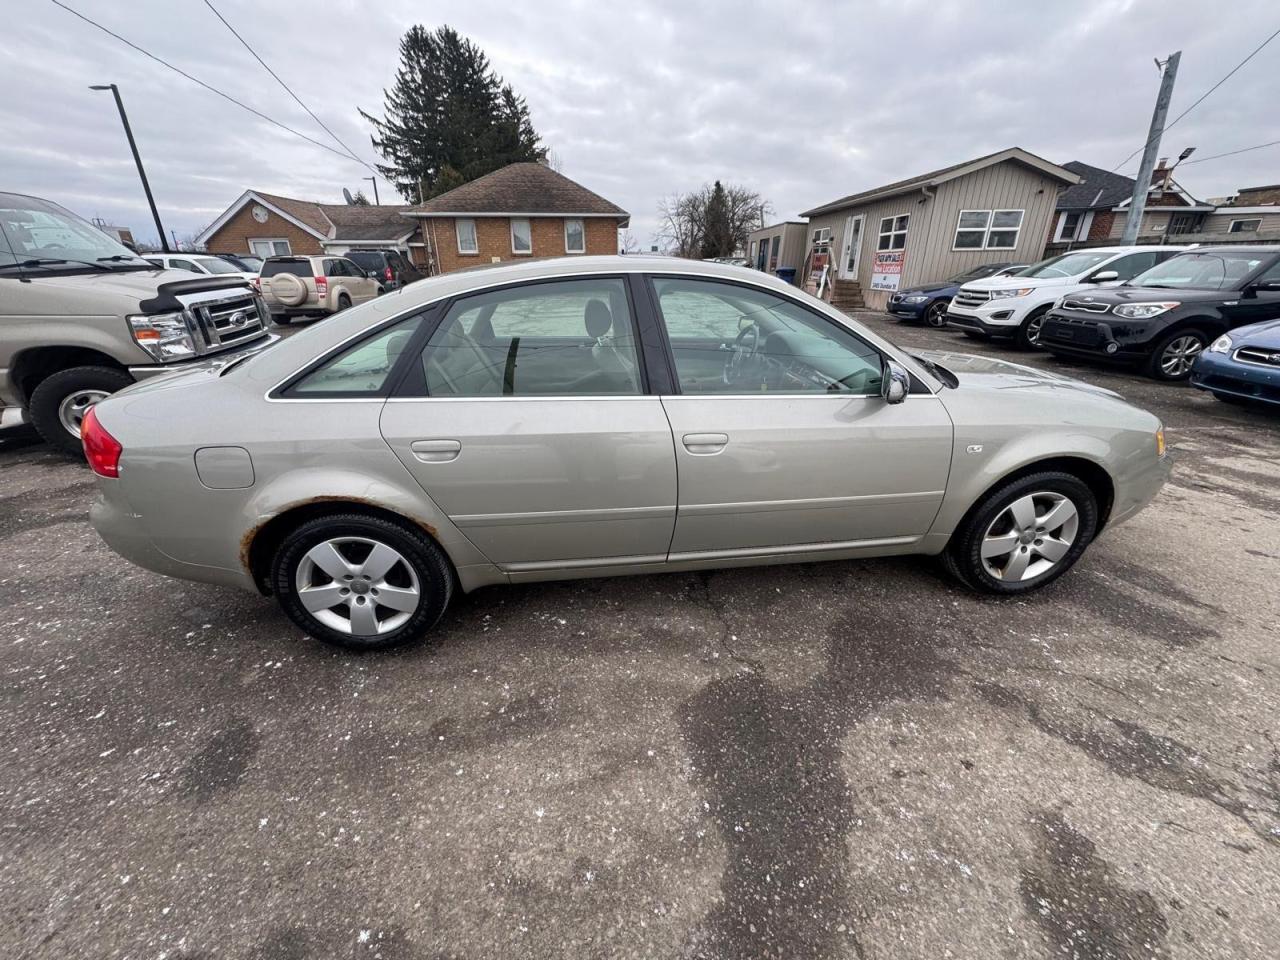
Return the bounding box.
[0,193,152,270]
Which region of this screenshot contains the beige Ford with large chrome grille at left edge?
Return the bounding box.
[0,193,279,454]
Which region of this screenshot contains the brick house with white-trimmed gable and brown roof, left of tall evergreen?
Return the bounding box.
[196,189,421,257]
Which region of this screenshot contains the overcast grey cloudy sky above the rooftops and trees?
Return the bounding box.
[0,0,1280,248]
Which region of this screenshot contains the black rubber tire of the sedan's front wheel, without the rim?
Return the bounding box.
[942,470,1098,596]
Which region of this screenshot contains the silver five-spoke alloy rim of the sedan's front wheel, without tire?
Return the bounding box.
[980,490,1080,582]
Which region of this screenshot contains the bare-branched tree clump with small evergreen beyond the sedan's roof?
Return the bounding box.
[658,180,773,257]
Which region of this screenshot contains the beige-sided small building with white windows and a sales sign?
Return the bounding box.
[803,147,1080,310]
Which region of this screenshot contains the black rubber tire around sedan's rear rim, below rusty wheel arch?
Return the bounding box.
[271,513,454,650]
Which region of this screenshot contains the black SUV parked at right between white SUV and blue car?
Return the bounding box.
[1041,246,1280,380]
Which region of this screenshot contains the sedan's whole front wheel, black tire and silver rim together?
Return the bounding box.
[942,471,1098,595]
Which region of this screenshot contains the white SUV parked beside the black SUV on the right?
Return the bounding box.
[947,246,1188,349]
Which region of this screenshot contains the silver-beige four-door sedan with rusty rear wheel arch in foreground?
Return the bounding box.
[83,256,1167,649]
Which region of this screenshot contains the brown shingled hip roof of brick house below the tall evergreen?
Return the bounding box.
[408,164,630,225]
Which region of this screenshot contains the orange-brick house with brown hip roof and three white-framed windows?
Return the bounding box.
[404,163,631,273]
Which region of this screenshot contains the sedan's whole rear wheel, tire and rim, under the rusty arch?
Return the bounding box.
[271,513,453,650]
